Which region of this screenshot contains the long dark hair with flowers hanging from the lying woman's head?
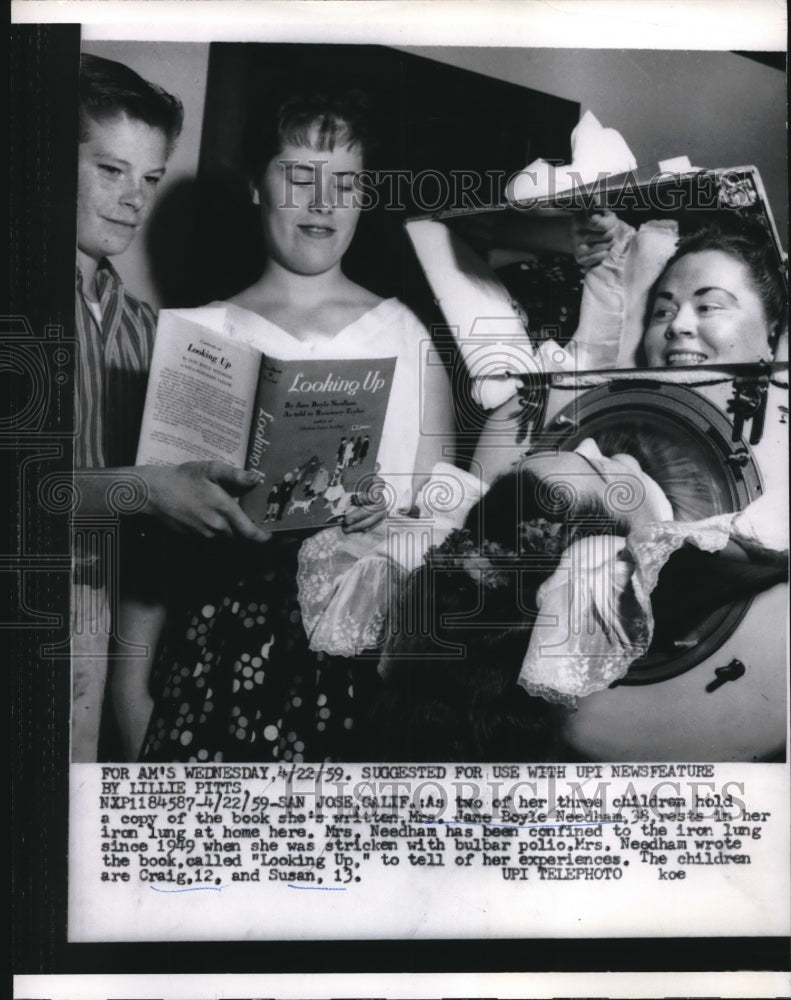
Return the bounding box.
[374,467,622,761]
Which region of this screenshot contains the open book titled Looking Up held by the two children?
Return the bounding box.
[136,308,396,531]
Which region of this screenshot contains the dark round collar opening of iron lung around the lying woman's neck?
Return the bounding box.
[546,382,762,684]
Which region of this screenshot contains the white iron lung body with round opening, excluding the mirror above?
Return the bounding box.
[476,364,788,761]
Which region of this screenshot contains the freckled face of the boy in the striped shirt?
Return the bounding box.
[77,114,167,261]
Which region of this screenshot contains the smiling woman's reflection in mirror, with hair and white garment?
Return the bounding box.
[460,211,787,411]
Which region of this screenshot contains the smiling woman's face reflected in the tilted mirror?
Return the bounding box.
[643,250,771,368]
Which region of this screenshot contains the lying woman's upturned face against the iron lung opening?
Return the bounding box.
[522,438,673,528]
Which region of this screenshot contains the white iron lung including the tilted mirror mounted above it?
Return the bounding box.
[407,166,788,761]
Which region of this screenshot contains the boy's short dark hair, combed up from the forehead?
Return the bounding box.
[80,53,184,156]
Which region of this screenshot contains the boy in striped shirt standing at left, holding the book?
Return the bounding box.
[72,55,267,761]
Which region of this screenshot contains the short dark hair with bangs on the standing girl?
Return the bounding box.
[247,90,375,180]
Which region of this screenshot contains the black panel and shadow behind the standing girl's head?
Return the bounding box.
[139,43,579,311]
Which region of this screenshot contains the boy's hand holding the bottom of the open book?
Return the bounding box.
[144,462,272,542]
